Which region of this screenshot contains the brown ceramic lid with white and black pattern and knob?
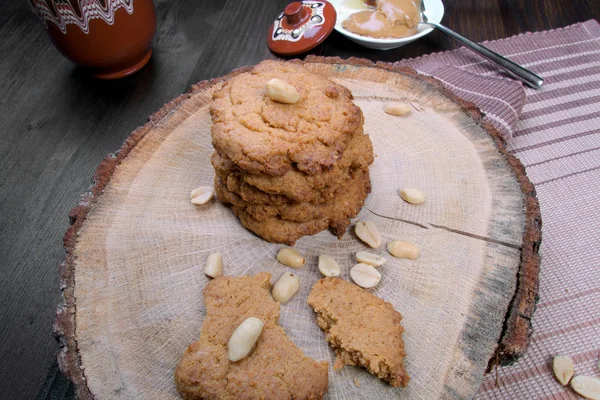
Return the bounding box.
[267,0,336,56]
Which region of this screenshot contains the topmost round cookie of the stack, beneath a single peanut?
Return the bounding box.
[210,60,363,176]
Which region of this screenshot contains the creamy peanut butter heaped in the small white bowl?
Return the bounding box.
[342,0,421,38]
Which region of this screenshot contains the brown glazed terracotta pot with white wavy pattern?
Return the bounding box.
[30,0,156,79]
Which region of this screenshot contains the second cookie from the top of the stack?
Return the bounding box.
[211,129,373,203]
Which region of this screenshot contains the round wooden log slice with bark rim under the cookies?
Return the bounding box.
[55,58,541,399]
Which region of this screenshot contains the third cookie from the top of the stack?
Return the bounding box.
[215,169,371,223]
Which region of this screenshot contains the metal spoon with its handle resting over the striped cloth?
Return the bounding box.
[421,0,544,89]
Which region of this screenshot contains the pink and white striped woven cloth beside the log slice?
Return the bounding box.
[398,20,600,399]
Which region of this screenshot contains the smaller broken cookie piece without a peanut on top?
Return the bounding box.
[308,278,410,387]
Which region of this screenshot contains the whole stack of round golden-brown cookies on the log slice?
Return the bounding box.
[210,61,373,245]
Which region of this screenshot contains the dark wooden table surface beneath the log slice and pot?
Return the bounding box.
[0,0,600,399]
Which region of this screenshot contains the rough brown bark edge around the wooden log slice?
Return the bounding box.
[52,56,542,400]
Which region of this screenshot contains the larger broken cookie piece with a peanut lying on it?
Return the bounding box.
[175,272,328,399]
